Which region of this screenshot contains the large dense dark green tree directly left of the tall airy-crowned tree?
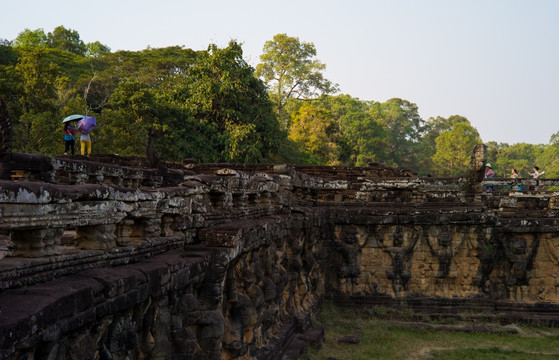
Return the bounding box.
[182,41,283,162]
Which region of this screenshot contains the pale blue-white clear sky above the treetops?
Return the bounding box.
[0,0,559,145]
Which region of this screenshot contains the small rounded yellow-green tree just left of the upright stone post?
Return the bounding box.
[433,122,481,176]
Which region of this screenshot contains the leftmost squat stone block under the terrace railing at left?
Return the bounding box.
[11,228,64,257]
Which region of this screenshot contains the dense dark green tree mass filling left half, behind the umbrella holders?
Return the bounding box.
[0,27,285,162]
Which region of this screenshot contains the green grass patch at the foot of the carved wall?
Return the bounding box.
[303,302,559,360]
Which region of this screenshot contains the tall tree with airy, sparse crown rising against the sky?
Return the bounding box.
[256,34,337,118]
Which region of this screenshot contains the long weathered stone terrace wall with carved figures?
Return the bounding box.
[0,147,559,360]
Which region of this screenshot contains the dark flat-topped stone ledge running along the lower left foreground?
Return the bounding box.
[0,252,210,358]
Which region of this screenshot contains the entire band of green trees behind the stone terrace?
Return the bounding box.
[0,26,559,177]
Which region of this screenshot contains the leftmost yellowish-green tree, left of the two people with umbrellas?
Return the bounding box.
[0,38,93,155]
